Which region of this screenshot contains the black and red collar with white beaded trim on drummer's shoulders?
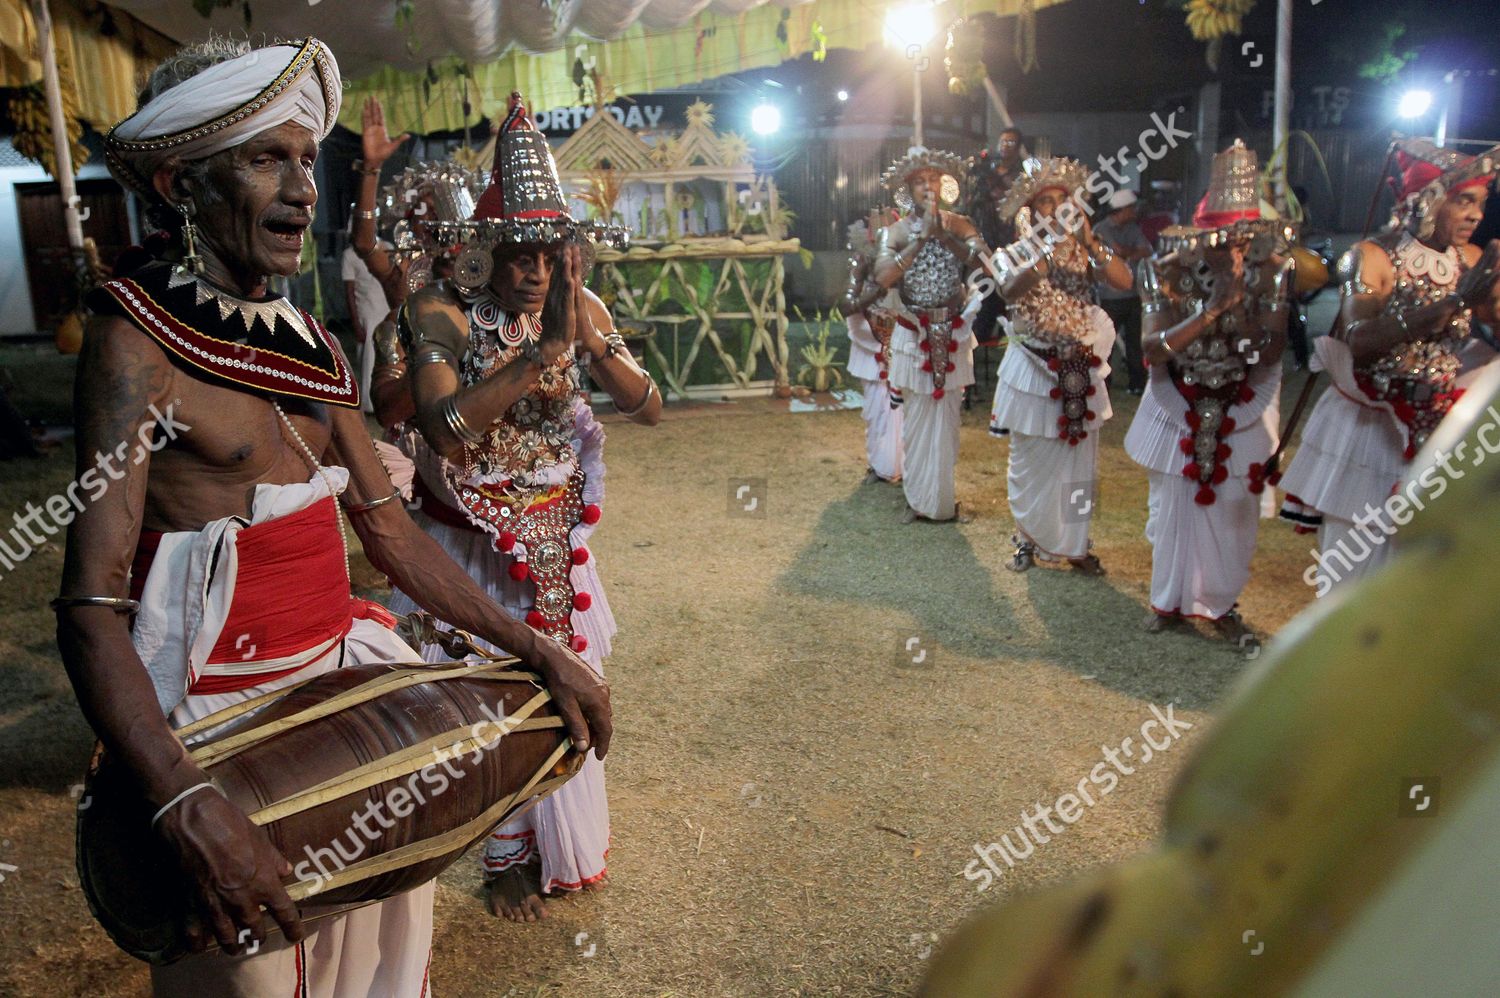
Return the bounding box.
[90,264,360,408]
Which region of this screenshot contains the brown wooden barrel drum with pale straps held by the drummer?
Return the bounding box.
[78,660,582,963]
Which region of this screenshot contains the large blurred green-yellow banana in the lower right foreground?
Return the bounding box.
[921,371,1500,998]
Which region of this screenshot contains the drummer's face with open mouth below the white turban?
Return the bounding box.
[194,122,318,276]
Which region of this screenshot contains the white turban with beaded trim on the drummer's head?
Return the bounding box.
[105,38,344,197]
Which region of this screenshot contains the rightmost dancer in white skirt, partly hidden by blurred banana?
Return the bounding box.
[1281,140,1500,596]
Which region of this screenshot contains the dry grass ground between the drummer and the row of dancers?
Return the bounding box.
[0,342,1311,998]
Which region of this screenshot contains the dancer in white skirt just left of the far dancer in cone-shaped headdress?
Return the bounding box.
[990,159,1131,575]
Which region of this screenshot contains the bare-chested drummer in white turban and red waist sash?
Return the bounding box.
[56,39,611,995]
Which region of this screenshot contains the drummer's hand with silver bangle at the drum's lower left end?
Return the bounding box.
[158,789,303,956]
